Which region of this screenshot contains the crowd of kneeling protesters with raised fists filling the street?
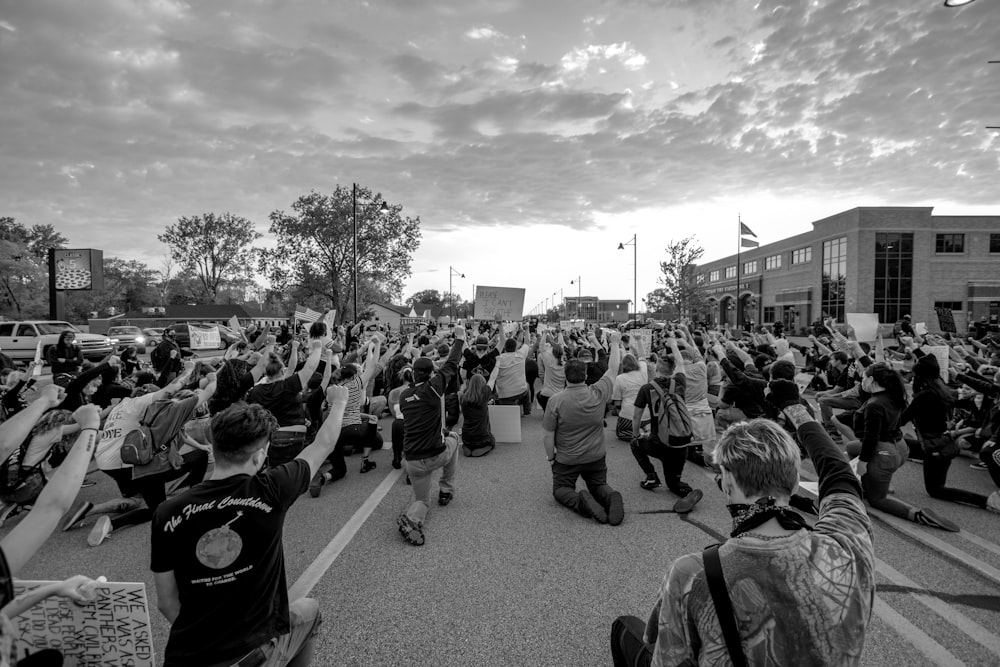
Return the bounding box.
[0,312,1000,665]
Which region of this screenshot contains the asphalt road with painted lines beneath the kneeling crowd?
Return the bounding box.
[0,386,1000,667]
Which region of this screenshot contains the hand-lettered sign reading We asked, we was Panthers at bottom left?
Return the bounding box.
[13,581,155,667]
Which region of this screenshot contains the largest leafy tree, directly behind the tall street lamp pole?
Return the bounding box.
[258,185,420,319]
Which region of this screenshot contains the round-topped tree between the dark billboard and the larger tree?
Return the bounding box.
[157,213,261,301]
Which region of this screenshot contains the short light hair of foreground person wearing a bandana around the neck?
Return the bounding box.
[713,419,801,497]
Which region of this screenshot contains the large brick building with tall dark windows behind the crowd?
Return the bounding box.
[697,207,1000,332]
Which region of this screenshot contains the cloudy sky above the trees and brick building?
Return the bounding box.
[0,0,1000,310]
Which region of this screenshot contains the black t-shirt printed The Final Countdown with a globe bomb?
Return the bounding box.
[151,459,310,667]
